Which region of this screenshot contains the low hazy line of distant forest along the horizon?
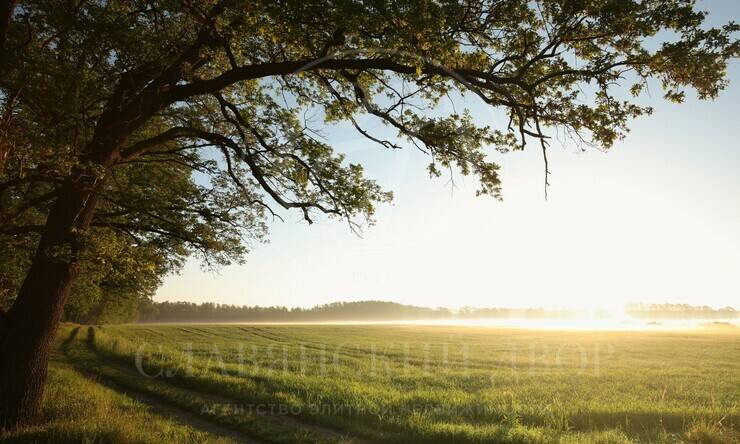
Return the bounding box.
[134,301,740,322]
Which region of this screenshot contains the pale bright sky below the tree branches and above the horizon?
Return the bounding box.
[155,0,740,309]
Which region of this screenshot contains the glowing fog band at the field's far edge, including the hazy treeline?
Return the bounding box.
[141,301,740,332]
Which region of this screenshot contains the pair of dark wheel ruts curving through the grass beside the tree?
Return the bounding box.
[81,327,370,444]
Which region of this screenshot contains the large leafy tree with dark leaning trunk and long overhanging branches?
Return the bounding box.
[0,0,740,425]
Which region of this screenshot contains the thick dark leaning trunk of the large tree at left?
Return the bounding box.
[0,166,104,428]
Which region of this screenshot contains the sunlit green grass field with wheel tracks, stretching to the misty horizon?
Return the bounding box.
[4,325,740,443]
